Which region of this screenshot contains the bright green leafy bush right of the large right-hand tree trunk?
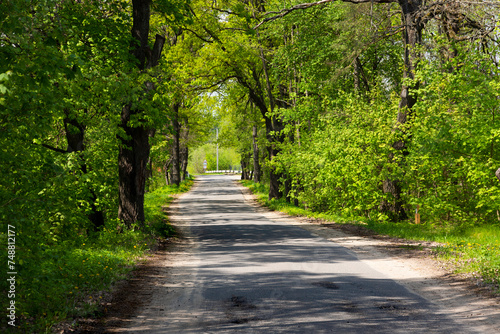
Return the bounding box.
[406,41,500,226]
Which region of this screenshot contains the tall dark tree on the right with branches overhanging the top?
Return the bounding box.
[255,0,498,220]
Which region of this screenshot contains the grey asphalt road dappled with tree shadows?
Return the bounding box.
[128,175,476,334]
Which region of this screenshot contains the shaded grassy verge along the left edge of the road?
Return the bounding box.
[12,180,193,333]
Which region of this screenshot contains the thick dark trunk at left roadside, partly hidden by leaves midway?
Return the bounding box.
[118,0,165,227]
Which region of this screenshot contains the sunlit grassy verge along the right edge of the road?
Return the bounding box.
[242,181,500,292]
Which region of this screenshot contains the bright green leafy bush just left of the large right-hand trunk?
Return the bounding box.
[274,93,398,219]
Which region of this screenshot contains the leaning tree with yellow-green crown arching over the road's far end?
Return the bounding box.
[172,1,292,198]
